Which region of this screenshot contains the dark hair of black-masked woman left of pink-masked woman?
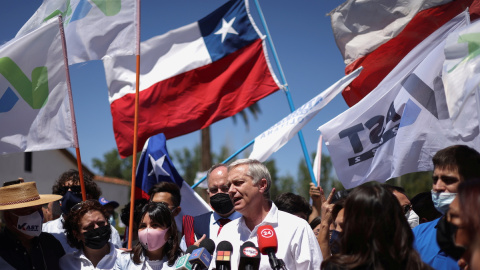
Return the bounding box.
[63,200,110,249]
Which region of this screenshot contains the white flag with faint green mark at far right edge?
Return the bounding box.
[442,18,480,123]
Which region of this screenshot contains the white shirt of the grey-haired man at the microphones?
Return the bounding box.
[210,202,323,270]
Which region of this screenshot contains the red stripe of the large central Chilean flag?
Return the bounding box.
[111,39,279,157]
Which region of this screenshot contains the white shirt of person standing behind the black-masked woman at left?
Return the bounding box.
[42,215,122,254]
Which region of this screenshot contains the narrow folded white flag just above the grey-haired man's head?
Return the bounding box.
[249,68,362,162]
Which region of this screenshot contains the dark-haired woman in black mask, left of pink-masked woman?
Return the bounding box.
[60,200,117,269]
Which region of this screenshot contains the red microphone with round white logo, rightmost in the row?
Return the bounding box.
[257,225,286,270]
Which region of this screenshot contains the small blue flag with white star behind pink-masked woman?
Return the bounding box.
[135,133,211,231]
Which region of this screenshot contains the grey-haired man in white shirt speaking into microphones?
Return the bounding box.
[215,159,323,270]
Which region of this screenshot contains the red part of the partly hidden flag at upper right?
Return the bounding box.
[334,0,478,106]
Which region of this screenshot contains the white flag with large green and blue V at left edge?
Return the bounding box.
[0,18,77,154]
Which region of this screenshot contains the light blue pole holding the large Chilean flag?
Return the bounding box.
[251,0,317,184]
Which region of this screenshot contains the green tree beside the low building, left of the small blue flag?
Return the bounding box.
[92,148,133,181]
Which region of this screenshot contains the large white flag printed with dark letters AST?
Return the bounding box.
[319,14,480,189]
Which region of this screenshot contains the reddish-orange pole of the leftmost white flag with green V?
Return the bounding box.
[58,15,87,201]
